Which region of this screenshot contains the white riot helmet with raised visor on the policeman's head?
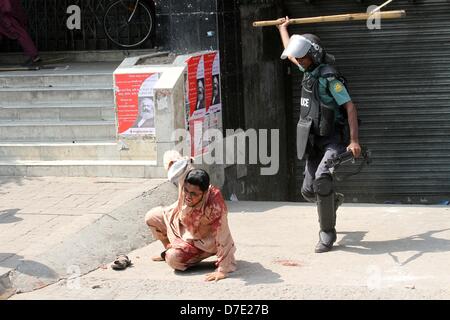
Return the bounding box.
[281,33,325,65]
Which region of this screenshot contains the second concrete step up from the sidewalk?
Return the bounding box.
[0,140,156,161]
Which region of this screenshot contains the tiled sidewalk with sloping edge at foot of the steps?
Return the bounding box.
[0,177,173,296]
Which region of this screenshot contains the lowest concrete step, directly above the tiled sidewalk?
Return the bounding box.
[0,160,167,178]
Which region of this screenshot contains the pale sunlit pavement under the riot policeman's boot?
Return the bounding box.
[13,202,450,300]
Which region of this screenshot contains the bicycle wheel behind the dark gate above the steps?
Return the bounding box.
[103,0,153,48]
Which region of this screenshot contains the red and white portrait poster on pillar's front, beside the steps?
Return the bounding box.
[114,73,159,135]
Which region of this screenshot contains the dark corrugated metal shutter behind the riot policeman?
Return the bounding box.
[284,0,450,203]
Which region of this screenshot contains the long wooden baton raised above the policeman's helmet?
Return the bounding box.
[253,10,406,27]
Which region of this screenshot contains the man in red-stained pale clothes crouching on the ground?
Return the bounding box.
[145,169,236,281]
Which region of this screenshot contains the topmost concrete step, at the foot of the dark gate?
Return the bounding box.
[0,49,158,64]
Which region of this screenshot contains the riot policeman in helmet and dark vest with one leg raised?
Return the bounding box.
[277,17,361,253]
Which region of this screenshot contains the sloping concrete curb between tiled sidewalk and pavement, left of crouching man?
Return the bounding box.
[7,182,178,299]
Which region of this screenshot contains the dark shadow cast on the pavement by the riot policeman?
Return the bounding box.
[336,228,450,266]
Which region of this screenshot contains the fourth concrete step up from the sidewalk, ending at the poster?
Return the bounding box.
[0,102,115,121]
